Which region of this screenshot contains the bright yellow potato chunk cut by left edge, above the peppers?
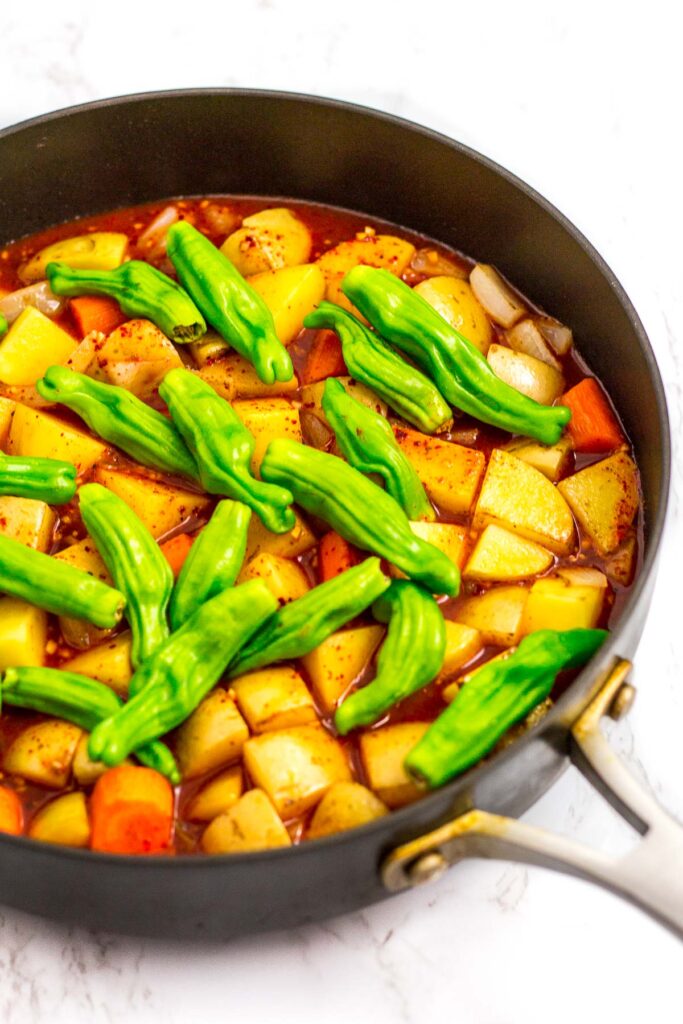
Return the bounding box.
[0,306,78,385]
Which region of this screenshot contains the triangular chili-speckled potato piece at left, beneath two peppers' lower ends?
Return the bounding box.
[94,466,212,540]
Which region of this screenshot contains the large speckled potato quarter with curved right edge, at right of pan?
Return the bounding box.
[473,449,574,555]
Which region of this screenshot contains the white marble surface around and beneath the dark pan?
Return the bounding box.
[0,0,683,1024]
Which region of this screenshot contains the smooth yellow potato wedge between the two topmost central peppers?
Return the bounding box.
[249,263,325,345]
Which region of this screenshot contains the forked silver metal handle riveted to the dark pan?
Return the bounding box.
[381,660,683,938]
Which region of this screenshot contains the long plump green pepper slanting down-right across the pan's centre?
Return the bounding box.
[261,438,460,596]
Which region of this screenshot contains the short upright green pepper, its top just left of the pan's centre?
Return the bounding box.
[169,499,251,630]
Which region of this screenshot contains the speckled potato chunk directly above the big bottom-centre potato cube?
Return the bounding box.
[230,666,317,732]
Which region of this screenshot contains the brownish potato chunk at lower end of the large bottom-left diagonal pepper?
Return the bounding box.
[176,689,249,778]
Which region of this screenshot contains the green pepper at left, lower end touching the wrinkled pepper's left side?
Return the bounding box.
[36,367,198,479]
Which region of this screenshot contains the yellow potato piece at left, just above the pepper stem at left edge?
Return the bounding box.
[7,403,106,476]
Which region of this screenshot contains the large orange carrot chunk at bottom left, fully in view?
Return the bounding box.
[90,765,173,853]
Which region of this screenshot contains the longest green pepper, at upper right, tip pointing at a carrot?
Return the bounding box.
[341,266,571,444]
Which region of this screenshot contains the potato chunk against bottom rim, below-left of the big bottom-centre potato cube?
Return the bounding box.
[202,790,292,853]
